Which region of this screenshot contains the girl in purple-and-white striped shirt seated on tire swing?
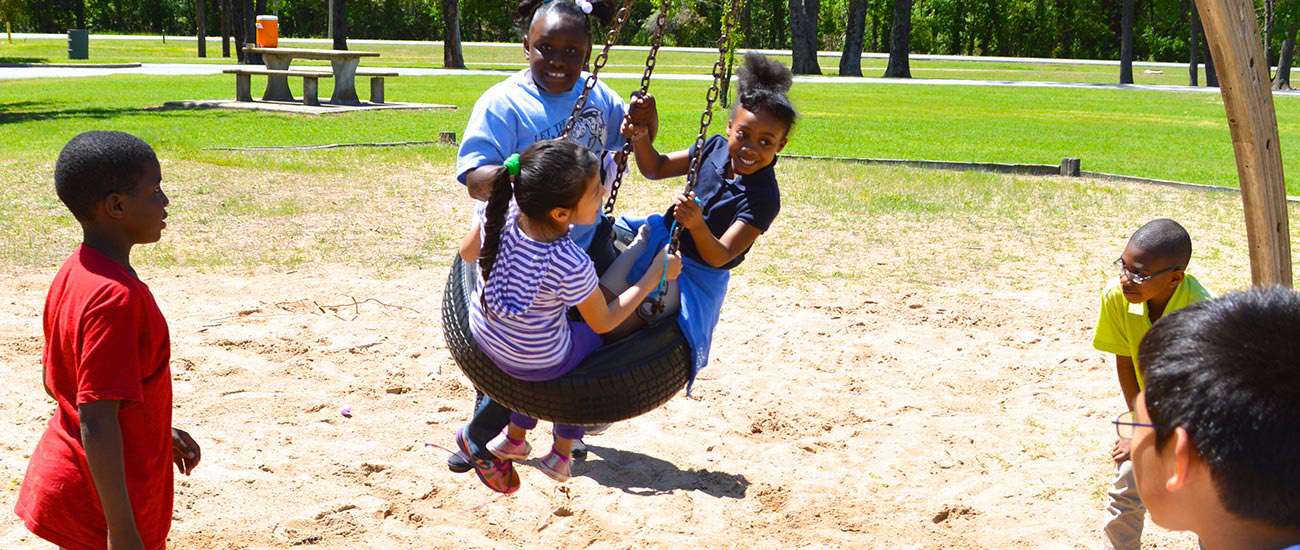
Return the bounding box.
[460,140,681,481]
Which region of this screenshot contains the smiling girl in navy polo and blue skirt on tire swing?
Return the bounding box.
[601,52,797,387]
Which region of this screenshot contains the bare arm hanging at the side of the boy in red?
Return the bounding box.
[77,400,144,550]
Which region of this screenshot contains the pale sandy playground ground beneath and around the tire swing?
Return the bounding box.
[0,154,1268,549]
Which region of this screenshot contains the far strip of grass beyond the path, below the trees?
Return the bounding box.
[0,36,1205,86]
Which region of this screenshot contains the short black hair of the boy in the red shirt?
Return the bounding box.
[55,131,159,221]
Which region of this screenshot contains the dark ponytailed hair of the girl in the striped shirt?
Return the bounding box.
[478,140,598,281]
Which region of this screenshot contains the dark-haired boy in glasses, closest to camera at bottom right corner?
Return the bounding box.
[1115,287,1300,550]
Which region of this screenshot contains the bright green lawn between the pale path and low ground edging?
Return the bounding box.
[0,73,1300,195]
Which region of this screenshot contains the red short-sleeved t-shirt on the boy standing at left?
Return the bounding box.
[14,244,172,550]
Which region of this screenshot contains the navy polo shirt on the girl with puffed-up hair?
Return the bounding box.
[664,135,781,269]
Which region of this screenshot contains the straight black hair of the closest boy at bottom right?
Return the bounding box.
[1138,287,1300,529]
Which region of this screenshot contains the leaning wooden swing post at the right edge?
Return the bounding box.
[1196,0,1291,286]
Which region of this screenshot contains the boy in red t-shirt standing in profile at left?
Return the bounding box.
[14,131,200,550]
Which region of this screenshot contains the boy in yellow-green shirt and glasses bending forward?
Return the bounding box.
[1092,218,1210,550]
